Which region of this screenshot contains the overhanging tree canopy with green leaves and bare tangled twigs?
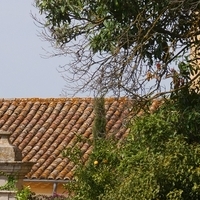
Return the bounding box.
[35,0,200,97]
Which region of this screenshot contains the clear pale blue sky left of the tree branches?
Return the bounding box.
[0,0,70,98]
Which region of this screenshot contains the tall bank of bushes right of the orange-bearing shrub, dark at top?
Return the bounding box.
[109,88,200,199]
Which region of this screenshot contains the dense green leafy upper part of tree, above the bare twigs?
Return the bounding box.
[36,0,199,61]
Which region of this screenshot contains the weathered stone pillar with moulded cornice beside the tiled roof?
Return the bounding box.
[0,131,34,200]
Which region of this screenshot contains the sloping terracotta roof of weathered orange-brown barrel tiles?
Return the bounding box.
[0,98,130,180]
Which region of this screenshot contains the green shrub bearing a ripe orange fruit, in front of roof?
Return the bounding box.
[65,138,120,200]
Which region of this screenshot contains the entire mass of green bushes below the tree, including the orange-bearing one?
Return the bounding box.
[63,88,200,200]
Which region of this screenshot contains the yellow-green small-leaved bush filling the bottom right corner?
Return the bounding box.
[103,136,200,200]
